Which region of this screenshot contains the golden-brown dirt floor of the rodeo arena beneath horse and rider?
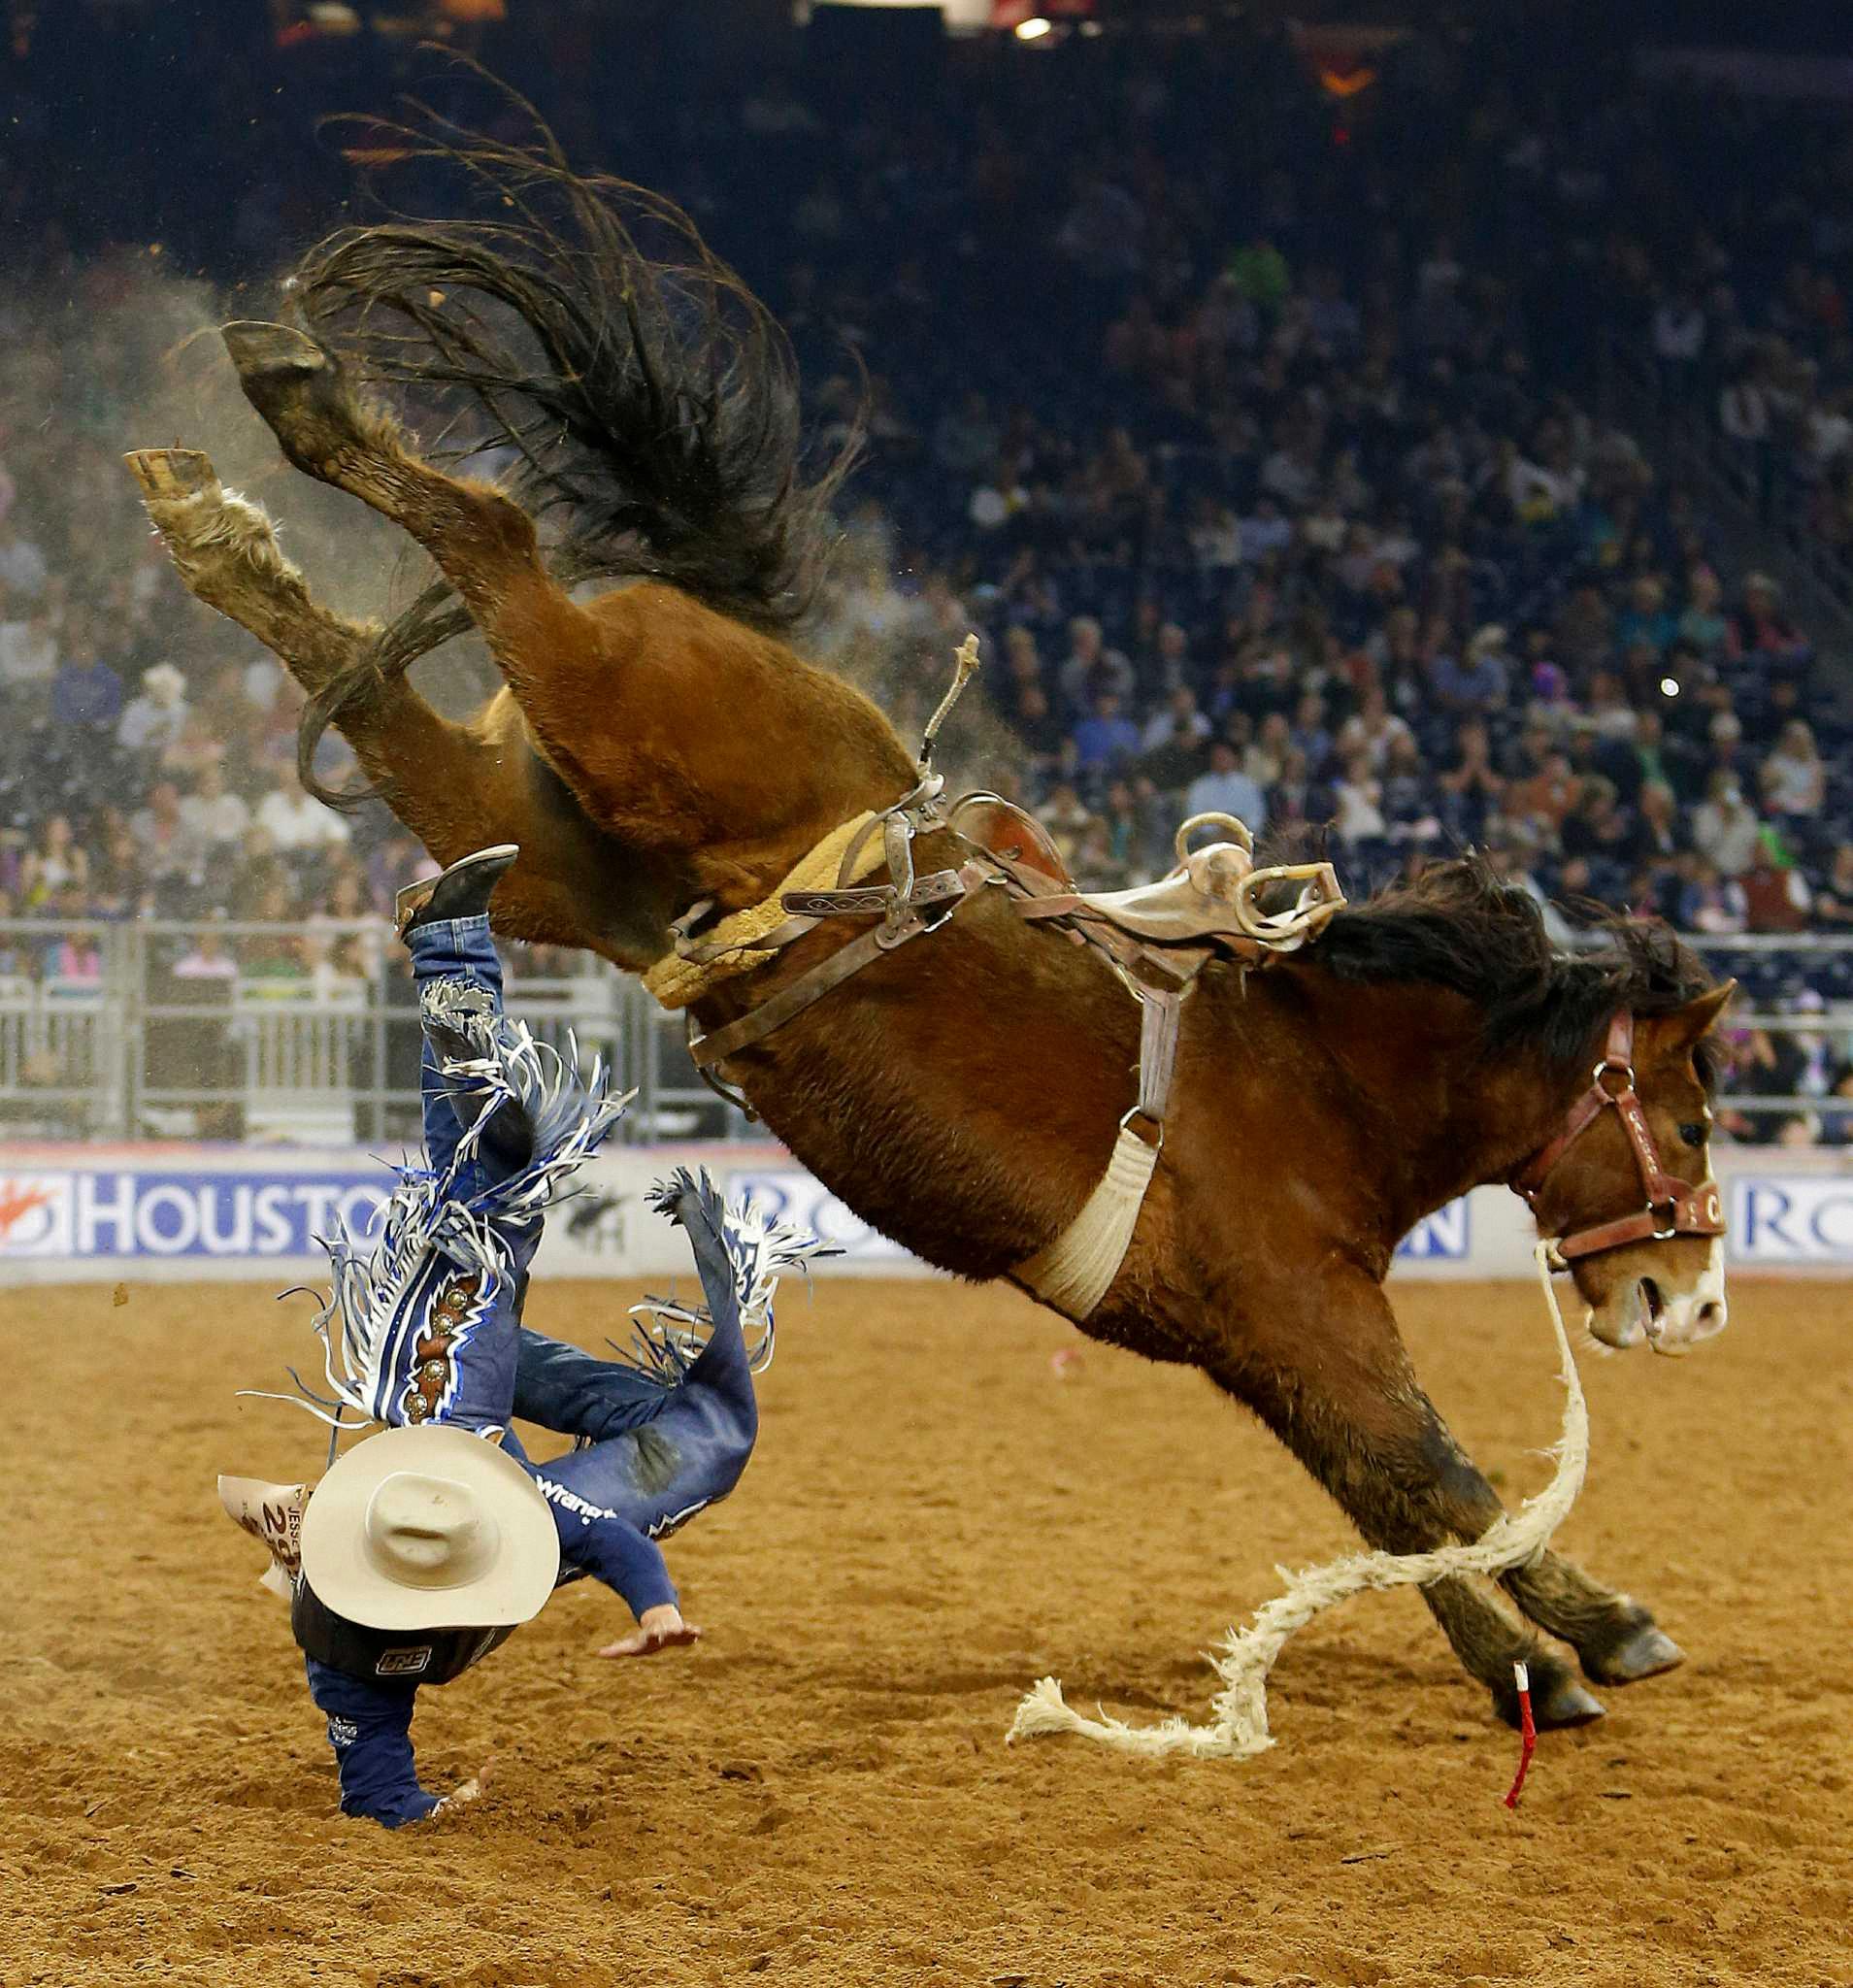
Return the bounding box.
[0,1280,1853,1988]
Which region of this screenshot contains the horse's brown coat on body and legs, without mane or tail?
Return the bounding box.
[122,158,1714,1722]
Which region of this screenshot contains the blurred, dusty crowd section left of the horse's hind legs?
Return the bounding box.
[0,376,433,1010]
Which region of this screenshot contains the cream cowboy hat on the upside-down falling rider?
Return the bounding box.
[302,1425,561,1628]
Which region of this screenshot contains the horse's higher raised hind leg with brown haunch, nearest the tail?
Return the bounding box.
[220,324,910,910]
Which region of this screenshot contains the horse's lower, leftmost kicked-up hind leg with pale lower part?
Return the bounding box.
[127,449,660,960]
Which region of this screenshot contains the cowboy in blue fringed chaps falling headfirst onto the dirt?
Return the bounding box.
[220,846,821,1827]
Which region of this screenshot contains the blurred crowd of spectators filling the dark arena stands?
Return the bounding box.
[0,12,1853,1142]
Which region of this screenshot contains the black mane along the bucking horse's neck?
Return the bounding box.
[1308,855,1712,1087]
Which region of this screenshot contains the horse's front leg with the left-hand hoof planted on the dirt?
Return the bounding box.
[1208,1265,1603,1726]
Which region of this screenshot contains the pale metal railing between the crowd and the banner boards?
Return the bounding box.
[0,918,1853,1145]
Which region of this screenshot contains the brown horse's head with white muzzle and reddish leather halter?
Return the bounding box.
[1515,982,1734,1354]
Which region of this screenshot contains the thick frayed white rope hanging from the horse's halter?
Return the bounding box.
[1010,1242,1589,1759]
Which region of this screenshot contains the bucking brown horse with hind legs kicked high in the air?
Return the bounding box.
[129,116,1730,1726]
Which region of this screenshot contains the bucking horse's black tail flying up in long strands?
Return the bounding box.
[294,83,861,636]
